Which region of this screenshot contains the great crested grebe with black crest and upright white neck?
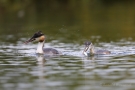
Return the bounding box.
[25,31,61,55]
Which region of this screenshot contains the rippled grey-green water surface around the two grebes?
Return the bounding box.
[0,34,135,90]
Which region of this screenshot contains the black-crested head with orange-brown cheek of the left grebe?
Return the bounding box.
[25,31,45,43]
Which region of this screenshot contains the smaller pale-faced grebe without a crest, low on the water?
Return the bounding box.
[83,42,111,56]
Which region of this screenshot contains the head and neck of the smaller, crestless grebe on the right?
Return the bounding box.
[83,41,94,56]
